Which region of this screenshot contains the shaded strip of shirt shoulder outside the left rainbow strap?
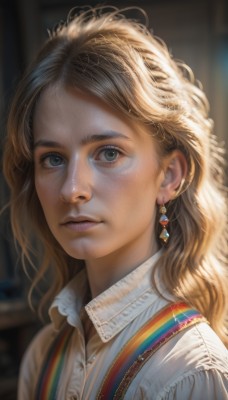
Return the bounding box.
[18,324,54,400]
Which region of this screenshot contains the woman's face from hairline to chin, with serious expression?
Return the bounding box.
[33,86,164,268]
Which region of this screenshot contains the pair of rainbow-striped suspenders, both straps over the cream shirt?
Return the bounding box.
[35,302,207,400]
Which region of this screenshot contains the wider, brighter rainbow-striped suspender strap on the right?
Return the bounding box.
[97,302,206,400]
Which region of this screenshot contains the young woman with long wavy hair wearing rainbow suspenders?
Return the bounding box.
[4,9,228,400]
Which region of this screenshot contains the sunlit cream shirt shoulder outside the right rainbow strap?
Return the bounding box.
[131,323,228,400]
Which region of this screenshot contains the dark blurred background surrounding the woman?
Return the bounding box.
[0,0,228,400]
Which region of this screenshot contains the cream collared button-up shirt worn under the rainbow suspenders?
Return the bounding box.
[18,252,228,400]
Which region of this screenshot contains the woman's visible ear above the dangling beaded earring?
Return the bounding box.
[157,150,188,205]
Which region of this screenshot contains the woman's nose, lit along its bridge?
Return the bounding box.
[60,158,92,203]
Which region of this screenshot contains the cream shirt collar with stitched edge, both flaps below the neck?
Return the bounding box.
[49,250,164,342]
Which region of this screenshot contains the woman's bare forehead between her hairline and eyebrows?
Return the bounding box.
[33,85,161,155]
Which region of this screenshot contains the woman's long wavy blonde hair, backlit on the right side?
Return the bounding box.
[4,7,227,342]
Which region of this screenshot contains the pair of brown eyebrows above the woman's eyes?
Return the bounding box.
[33,131,130,149]
